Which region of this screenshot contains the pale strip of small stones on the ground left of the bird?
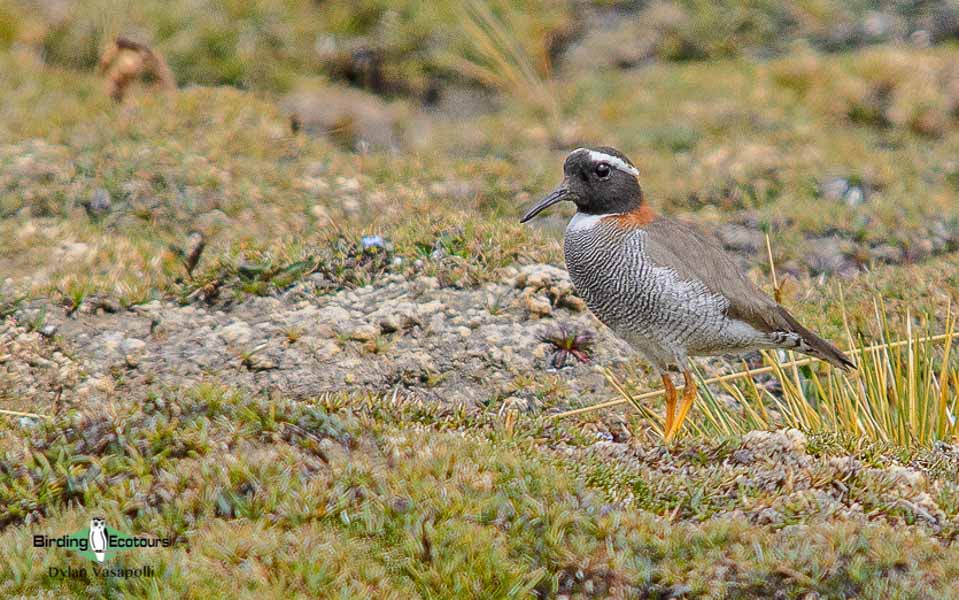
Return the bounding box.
[0,265,622,410]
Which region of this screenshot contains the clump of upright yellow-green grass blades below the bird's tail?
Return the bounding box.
[703,304,959,446]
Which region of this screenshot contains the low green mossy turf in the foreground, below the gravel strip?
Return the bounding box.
[0,385,959,597]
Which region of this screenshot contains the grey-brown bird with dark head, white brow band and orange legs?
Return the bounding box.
[520,146,855,443]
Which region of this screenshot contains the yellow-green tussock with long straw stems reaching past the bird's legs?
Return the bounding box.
[568,300,959,446]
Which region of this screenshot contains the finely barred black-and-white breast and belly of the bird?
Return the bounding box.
[563,213,766,369]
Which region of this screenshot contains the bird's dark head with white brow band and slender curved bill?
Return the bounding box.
[520,146,643,223]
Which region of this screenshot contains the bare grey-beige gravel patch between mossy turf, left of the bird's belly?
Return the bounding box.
[0,264,644,407]
